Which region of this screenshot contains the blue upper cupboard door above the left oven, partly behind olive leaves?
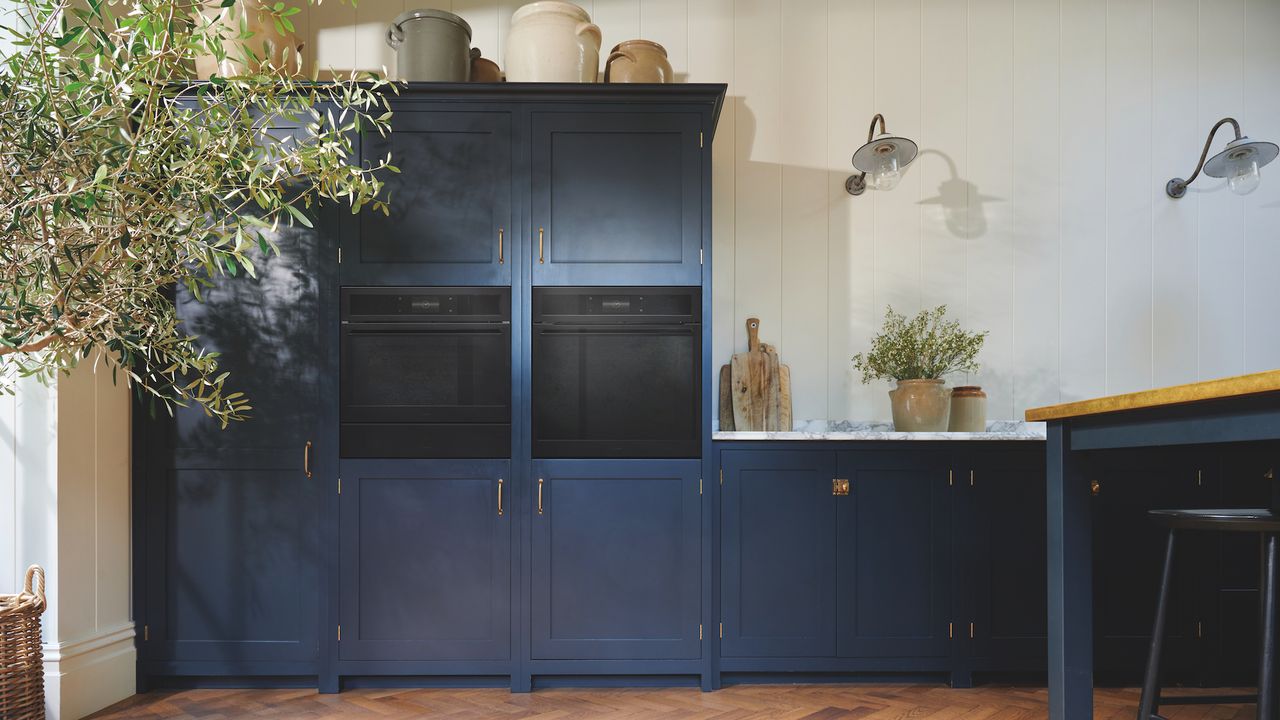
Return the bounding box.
[342,106,516,284]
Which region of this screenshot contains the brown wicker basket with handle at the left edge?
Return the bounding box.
[0,565,45,720]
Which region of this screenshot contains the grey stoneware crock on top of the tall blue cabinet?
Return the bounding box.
[387,9,471,82]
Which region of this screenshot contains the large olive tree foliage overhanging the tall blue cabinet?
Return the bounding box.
[0,0,394,425]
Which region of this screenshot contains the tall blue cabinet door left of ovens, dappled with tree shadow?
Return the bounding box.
[134,189,337,675]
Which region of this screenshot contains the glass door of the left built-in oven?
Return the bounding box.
[342,323,511,423]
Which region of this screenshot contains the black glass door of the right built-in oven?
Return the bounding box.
[531,324,701,457]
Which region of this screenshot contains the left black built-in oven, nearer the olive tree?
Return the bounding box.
[339,287,511,457]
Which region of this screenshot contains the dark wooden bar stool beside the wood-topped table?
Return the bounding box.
[1138,509,1280,720]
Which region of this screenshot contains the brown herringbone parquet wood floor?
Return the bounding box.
[85,684,1254,720]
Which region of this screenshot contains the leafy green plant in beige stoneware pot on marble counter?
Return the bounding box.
[854,305,987,432]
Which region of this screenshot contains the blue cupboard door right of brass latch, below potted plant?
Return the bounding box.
[836,451,951,657]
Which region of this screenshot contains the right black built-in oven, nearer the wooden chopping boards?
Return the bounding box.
[530,287,701,457]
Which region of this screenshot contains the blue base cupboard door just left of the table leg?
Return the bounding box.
[957,447,1048,670]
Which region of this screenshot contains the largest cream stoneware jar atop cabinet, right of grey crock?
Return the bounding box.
[506,0,600,82]
